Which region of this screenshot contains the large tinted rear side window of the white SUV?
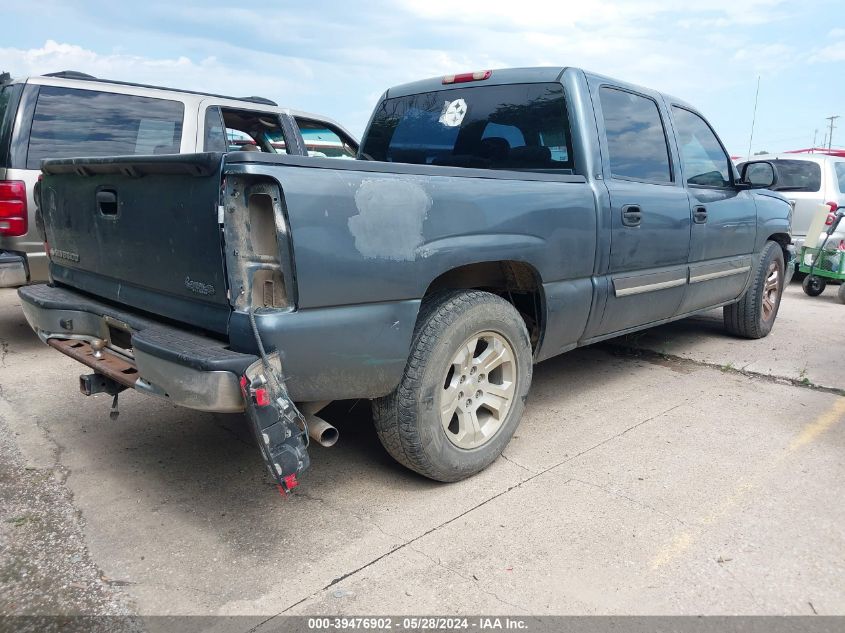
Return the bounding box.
[26,86,184,169]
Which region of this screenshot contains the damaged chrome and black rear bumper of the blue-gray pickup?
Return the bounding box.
[18,285,258,413]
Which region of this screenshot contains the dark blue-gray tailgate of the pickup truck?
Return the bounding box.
[41,153,231,334]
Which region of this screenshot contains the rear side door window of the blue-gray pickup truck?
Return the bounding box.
[599,86,672,183]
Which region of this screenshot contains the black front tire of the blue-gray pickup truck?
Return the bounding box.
[723,242,784,339]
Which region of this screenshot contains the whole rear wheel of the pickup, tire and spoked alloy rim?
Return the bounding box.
[373,290,532,481]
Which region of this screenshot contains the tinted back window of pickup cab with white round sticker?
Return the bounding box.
[360,84,572,173]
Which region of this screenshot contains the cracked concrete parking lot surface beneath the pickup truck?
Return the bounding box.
[0,284,845,626]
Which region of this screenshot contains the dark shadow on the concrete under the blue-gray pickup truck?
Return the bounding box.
[66,338,660,507]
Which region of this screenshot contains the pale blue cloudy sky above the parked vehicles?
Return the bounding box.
[0,0,845,156]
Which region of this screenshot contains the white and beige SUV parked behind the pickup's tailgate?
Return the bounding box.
[0,71,358,287]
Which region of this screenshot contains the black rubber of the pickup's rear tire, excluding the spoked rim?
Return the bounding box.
[373,290,532,482]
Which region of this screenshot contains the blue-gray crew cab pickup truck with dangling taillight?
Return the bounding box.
[19,68,792,490]
